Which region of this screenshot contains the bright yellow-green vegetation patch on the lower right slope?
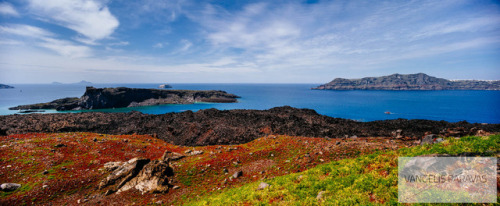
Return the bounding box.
[188,135,500,205]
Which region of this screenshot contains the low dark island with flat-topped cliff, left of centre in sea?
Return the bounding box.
[9,87,239,111]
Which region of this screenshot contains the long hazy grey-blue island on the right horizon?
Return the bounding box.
[312,73,500,90]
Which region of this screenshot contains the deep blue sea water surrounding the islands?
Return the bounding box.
[0,84,500,123]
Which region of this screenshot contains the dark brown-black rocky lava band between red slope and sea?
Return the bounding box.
[0,106,500,146]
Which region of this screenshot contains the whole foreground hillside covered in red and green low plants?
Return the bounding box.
[0,133,500,205]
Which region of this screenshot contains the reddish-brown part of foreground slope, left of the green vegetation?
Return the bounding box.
[0,133,413,205]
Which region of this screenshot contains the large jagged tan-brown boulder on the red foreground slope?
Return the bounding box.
[99,151,174,195]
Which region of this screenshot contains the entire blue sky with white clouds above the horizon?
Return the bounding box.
[0,0,500,84]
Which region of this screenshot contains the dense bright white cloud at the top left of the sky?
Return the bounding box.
[29,0,119,43]
